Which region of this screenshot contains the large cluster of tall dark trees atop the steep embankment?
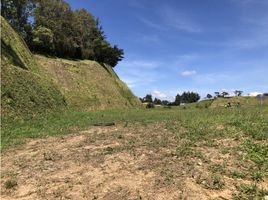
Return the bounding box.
[1,0,124,67]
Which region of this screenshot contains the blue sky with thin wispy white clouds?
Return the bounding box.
[67,0,268,100]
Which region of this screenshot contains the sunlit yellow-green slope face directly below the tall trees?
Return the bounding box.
[36,55,141,111]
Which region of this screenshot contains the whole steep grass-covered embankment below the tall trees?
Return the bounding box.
[1,17,140,118]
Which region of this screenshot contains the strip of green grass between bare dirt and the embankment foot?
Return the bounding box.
[1,107,268,149]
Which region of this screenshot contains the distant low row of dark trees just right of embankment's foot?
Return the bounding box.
[140,92,200,106]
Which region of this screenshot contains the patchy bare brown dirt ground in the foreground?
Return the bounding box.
[1,123,267,200]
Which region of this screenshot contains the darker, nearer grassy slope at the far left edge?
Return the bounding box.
[1,17,66,118]
